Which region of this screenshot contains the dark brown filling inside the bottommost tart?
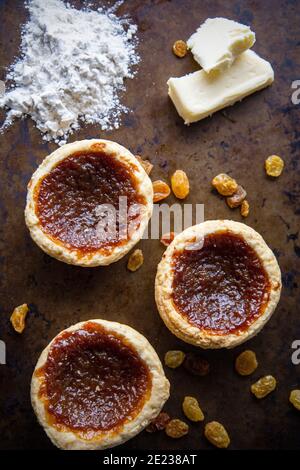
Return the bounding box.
[37,322,151,432]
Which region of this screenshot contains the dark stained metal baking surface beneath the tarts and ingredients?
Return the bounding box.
[0,0,300,449]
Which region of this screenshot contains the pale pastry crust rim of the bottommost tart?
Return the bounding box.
[31,319,170,450]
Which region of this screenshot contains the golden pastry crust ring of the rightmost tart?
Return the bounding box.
[155,220,282,349]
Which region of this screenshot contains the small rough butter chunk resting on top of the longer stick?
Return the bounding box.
[187,18,255,73]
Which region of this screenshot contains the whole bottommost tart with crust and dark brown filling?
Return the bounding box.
[31,320,169,450]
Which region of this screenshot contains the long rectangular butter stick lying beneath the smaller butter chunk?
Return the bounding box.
[168,51,274,124]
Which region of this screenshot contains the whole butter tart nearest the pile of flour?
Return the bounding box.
[25,139,153,266]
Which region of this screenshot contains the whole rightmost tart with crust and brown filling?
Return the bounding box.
[155,220,281,348]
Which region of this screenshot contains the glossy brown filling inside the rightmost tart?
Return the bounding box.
[173,231,270,334]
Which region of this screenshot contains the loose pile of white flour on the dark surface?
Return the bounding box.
[0,0,139,144]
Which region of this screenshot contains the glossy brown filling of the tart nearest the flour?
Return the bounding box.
[36,151,145,254]
